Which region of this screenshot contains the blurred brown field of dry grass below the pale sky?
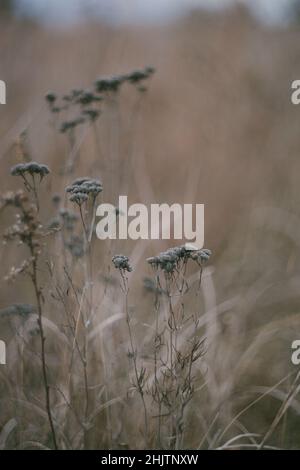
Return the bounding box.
[0,2,300,449]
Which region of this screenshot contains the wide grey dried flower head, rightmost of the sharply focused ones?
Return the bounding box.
[147,245,211,274]
